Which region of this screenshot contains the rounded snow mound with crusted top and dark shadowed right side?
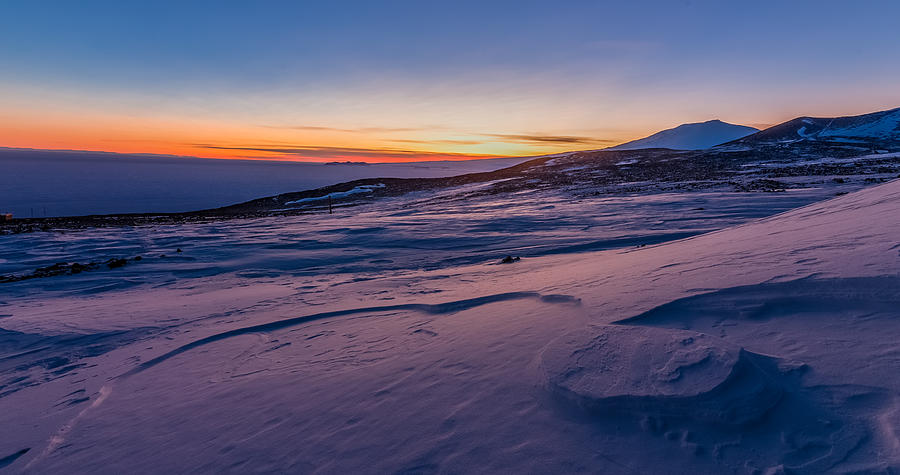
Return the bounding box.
[542,325,782,426]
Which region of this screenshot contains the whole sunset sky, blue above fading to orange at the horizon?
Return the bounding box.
[0,0,900,162]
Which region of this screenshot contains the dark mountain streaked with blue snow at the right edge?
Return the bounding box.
[734,107,900,145]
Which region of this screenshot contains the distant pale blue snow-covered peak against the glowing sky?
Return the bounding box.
[607,119,759,150]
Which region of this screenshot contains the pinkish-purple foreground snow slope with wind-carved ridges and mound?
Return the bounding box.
[0,177,900,473]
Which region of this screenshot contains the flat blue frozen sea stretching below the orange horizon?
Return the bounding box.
[0,148,527,217]
